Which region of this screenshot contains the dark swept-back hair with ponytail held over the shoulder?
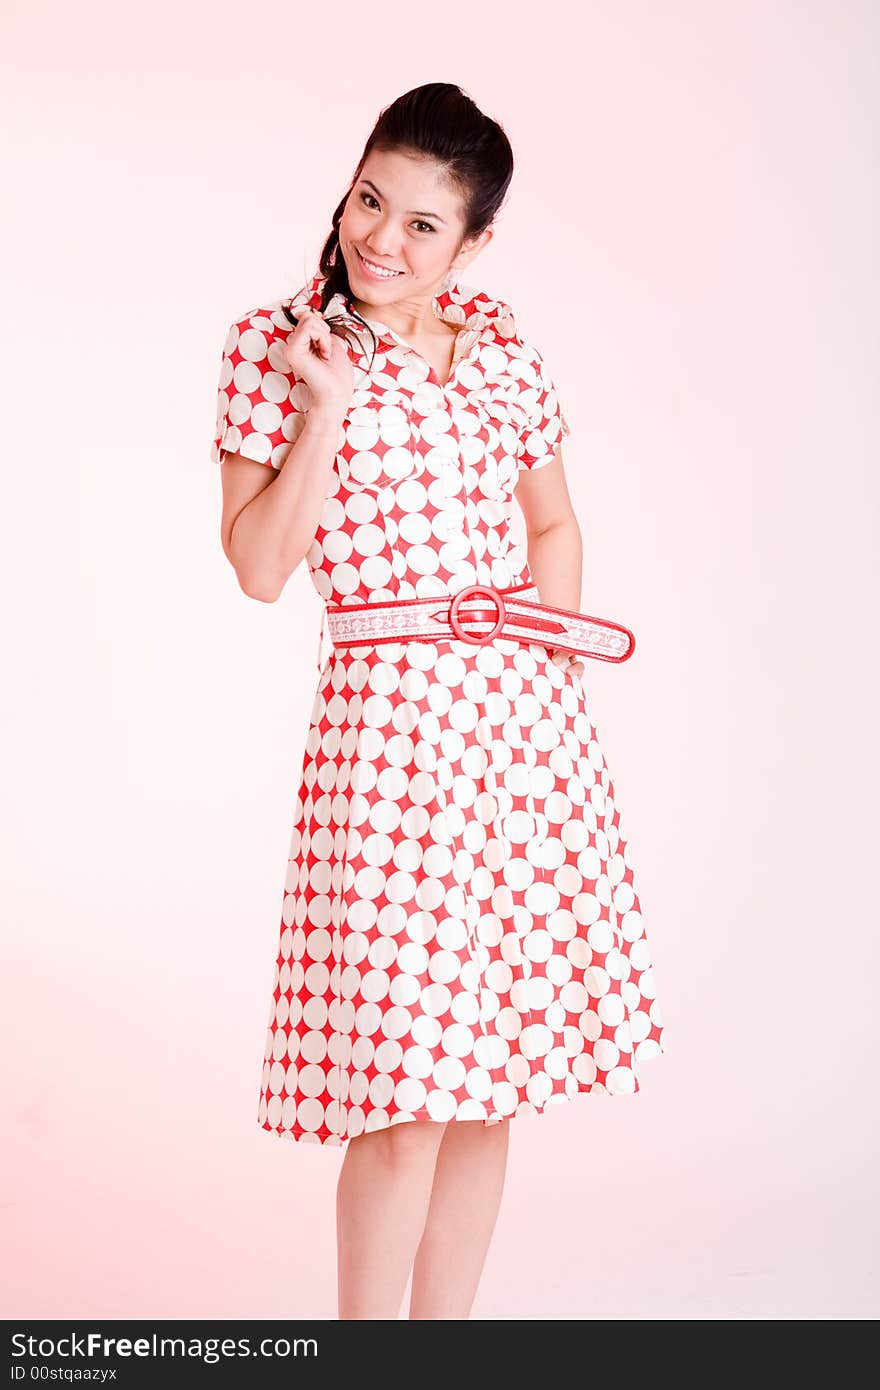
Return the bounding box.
[284,82,513,369]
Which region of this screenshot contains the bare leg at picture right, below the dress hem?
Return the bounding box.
[409,1120,510,1319]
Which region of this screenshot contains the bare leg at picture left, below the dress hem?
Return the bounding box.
[336,1120,446,1319]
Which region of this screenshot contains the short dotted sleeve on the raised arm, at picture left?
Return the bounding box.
[211,304,309,468]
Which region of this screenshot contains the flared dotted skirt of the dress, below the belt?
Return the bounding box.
[259,639,663,1145]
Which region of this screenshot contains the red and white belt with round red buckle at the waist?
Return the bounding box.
[318,584,635,669]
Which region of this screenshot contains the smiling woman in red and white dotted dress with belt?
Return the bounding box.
[213,83,663,1319]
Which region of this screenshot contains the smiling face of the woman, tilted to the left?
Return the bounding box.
[339,150,492,307]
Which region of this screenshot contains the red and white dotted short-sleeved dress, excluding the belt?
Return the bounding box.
[211,265,665,1145]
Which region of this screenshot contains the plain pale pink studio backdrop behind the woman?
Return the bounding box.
[0,0,880,1319]
